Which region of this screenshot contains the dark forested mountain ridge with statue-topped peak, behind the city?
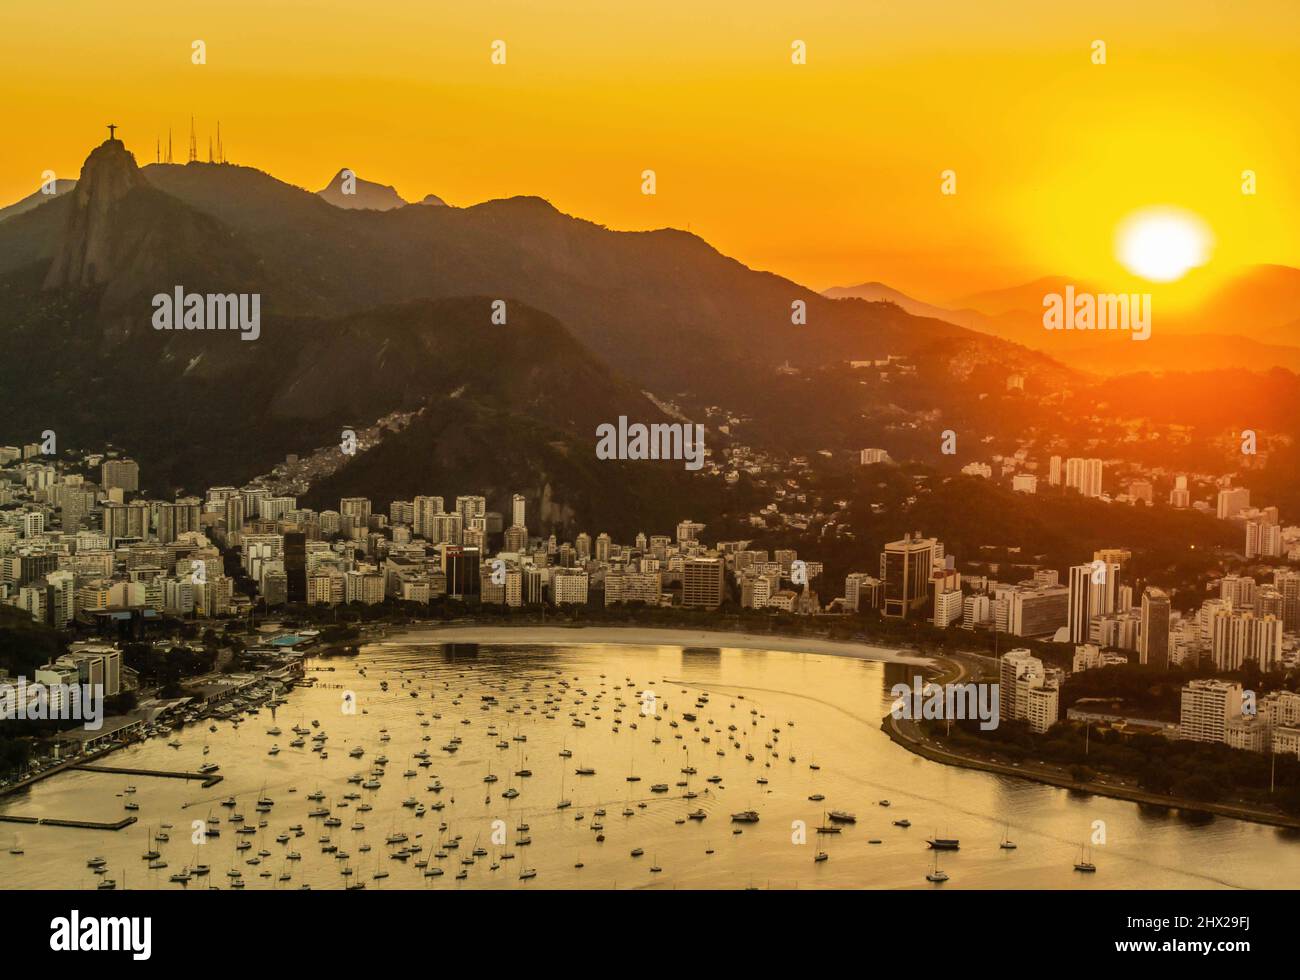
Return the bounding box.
[0,140,1286,532]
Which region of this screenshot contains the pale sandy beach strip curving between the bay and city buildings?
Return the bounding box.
[377,624,935,667]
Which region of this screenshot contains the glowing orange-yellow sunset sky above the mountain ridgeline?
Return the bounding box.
[0,0,1300,302]
